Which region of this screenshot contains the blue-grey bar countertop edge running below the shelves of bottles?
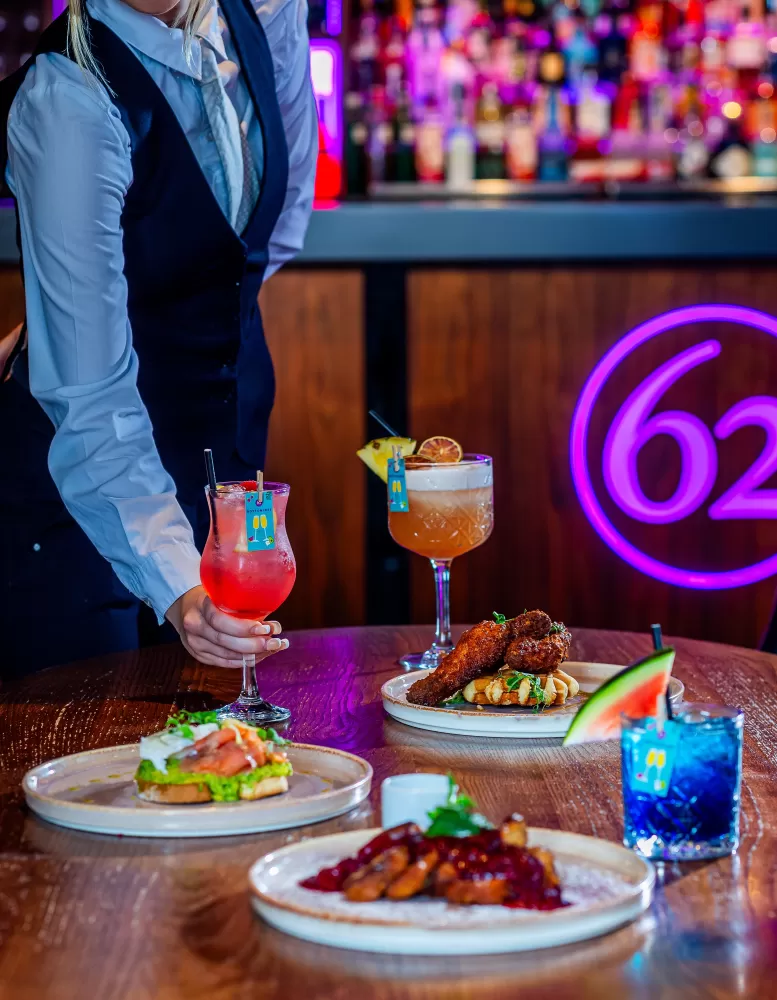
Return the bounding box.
[0,195,777,266]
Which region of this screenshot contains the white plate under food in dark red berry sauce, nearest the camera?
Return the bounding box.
[249,828,655,955]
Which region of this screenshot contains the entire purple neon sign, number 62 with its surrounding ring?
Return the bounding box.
[570,305,777,590]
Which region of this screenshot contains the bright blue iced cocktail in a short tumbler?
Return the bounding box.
[621,704,743,861]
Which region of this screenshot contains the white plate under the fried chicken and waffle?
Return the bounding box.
[380,660,685,739]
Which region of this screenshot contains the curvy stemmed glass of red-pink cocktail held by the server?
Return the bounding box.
[201,483,297,725]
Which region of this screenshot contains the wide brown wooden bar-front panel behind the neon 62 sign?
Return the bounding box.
[408,267,777,645]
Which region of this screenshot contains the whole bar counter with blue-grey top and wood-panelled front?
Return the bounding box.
[0,196,777,646]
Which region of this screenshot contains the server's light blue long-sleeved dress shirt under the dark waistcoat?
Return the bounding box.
[7,0,318,621]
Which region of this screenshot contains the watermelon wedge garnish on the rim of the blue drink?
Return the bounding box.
[564,649,674,746]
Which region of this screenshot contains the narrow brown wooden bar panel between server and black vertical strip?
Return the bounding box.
[261,270,366,628]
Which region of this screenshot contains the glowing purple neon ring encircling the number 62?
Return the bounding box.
[569,305,777,590]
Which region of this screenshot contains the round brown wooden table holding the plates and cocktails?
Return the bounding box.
[0,628,777,1000]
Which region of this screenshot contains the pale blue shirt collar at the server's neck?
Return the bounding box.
[87,0,226,80]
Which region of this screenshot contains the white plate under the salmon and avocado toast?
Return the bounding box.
[22,743,372,837]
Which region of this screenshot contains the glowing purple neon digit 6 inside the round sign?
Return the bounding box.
[602,340,721,524]
